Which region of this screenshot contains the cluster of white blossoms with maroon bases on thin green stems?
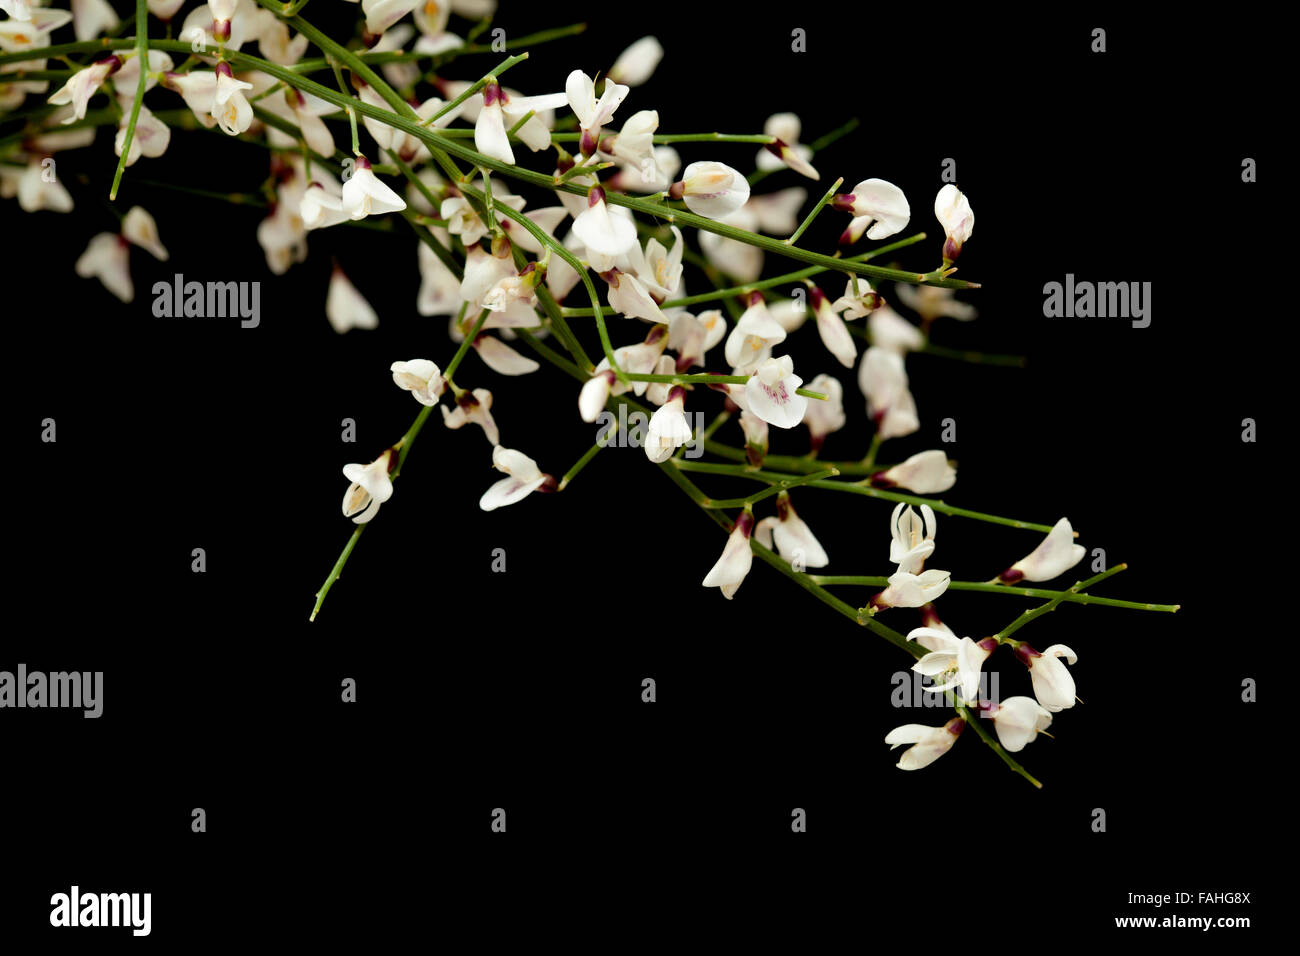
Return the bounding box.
[0,0,1180,785]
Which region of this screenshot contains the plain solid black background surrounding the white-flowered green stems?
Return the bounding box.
[0,3,1290,946]
